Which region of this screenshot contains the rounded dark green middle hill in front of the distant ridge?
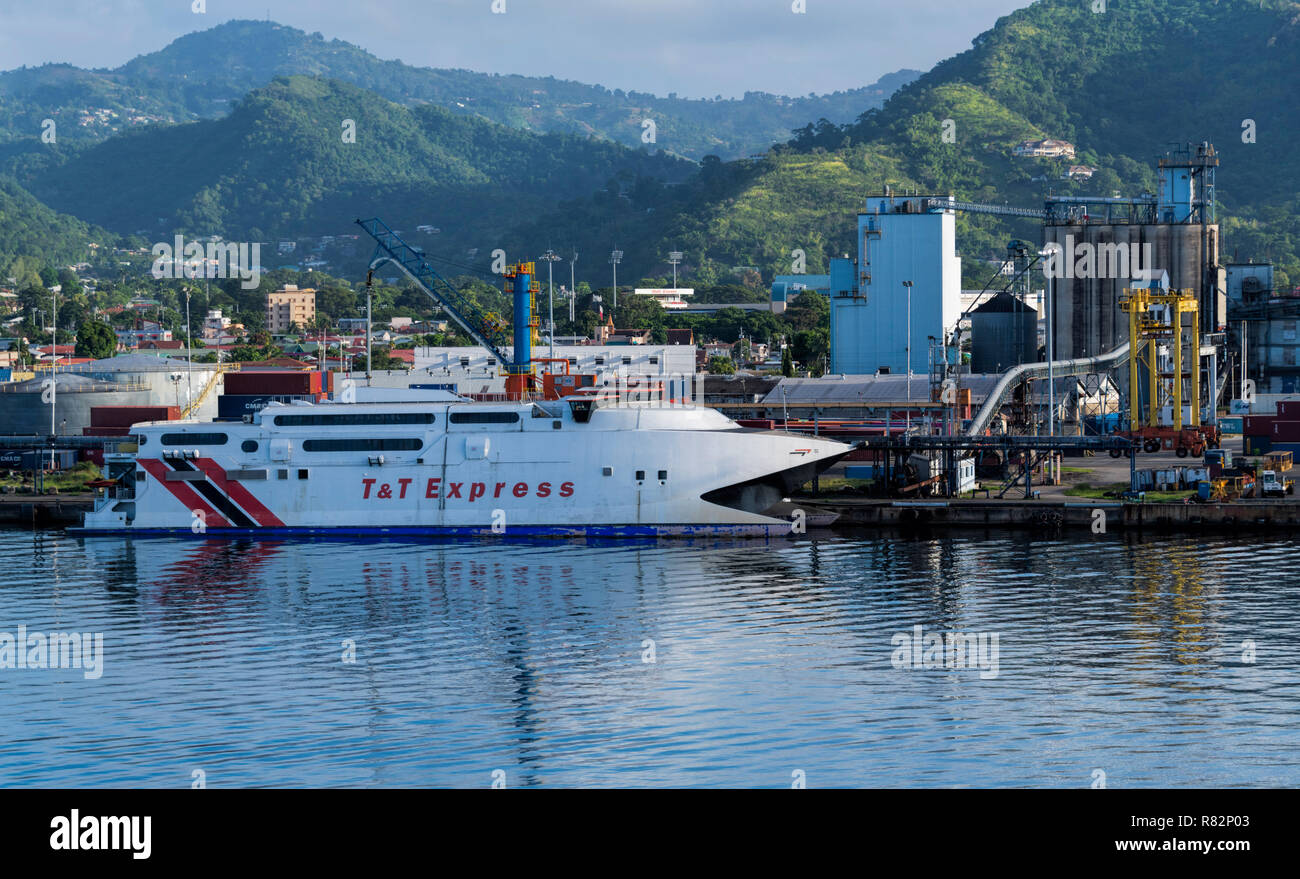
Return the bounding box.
[22,77,694,254]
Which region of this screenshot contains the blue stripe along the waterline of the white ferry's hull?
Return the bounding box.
[68,523,792,540]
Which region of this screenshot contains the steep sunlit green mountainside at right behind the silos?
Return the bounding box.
[629,0,1300,285]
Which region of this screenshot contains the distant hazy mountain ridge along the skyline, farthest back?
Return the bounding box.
[0,21,919,160]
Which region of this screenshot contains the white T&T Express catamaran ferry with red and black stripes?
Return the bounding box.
[74,395,850,536]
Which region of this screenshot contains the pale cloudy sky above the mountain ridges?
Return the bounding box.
[0,0,1030,98]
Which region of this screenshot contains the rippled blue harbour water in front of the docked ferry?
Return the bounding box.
[0,531,1300,787]
